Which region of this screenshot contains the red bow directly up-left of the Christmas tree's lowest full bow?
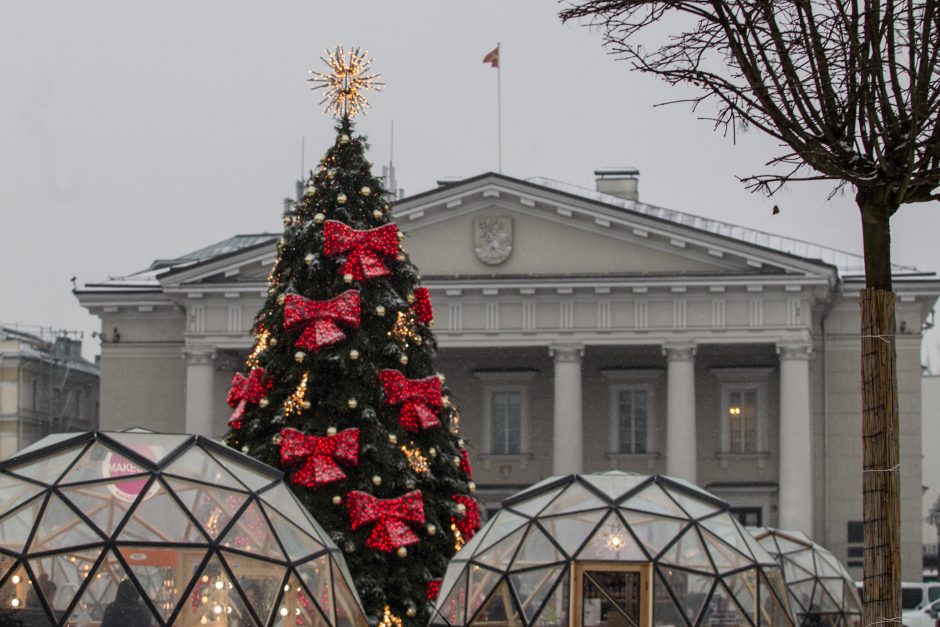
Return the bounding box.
[281,428,359,489]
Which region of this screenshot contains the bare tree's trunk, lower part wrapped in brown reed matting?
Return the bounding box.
[856,191,901,625]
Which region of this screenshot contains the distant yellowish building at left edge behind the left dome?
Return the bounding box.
[0,325,101,459]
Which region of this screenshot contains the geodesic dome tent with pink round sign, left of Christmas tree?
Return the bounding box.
[0,429,366,626]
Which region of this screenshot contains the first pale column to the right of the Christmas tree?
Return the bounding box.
[551,346,584,475]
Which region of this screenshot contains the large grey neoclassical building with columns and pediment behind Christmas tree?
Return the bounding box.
[76,169,940,578]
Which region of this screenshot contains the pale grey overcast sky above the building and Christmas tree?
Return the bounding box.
[0,0,940,355]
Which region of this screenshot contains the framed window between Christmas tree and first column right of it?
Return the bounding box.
[473,370,536,455]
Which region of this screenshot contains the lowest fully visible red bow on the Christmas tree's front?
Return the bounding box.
[346,490,424,552]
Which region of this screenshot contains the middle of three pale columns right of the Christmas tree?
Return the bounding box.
[663,345,698,483]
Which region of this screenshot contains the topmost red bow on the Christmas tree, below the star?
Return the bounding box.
[323,220,398,281]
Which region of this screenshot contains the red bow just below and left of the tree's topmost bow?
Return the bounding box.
[284,290,362,352]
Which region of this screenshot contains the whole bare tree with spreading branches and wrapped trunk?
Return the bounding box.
[561,0,940,625]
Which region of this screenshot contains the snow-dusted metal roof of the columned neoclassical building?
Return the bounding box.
[84,175,929,291]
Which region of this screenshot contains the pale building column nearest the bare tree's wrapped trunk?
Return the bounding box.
[777,345,813,538]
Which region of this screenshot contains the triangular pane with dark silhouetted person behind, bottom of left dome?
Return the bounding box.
[64,551,156,625]
